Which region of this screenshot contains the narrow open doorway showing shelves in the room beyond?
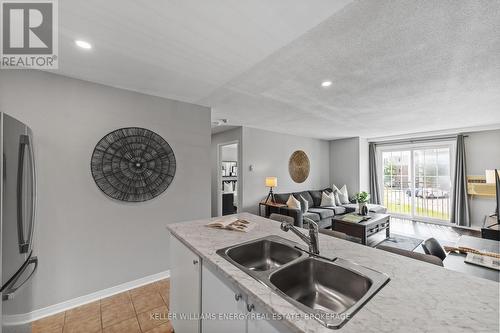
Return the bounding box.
[217,141,240,216]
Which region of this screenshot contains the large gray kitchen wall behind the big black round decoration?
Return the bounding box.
[0,70,211,312]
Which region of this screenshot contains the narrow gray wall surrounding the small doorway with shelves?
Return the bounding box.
[210,127,243,217]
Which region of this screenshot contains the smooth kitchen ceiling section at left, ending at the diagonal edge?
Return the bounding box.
[57,0,351,102]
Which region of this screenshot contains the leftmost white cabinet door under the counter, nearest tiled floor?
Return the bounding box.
[170,235,201,333]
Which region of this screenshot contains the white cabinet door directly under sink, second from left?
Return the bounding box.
[201,266,246,333]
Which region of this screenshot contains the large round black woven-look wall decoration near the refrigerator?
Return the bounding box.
[91,127,176,202]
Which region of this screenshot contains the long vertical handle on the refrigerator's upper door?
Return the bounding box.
[17,134,36,253]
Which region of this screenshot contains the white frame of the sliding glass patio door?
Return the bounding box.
[376,140,456,226]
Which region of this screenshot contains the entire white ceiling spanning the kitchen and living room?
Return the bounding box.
[52,0,500,139]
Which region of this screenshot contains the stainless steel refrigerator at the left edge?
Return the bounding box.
[0,113,38,333]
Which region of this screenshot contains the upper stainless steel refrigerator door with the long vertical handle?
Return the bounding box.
[1,114,36,287]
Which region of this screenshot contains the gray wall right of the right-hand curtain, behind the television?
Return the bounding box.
[465,130,500,227]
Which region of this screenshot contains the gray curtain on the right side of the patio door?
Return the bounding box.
[451,134,471,227]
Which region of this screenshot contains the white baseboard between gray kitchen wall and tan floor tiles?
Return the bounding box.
[2,271,170,326]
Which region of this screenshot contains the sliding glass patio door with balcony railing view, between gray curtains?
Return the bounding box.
[379,143,454,222]
